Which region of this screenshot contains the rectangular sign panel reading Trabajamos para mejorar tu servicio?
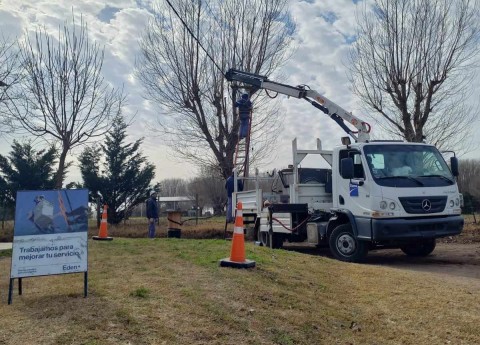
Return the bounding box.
[10,189,88,278]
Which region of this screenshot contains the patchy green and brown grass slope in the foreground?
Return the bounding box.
[0,238,480,345]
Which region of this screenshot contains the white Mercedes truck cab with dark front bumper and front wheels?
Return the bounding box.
[327,141,463,261]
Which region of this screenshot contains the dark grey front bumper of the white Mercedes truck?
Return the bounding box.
[372,215,464,241]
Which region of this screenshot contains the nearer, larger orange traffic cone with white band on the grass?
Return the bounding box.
[220,201,255,268]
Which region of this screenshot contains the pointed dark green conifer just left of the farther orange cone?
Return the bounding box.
[79,116,155,224]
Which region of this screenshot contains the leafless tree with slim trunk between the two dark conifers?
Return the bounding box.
[10,18,124,188]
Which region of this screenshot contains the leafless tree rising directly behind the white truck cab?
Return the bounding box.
[349,0,480,149]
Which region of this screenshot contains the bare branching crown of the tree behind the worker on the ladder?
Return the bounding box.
[137,0,295,177]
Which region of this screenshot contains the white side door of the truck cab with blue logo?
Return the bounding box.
[334,149,370,217]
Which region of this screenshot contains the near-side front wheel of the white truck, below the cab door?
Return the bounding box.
[329,224,368,262]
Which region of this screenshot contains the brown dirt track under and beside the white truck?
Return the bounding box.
[285,243,480,288]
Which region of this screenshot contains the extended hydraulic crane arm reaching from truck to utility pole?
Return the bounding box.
[225,69,370,142]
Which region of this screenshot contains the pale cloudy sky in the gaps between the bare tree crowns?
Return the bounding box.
[0,0,476,181]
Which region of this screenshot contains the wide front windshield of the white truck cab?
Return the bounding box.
[364,144,455,187]
